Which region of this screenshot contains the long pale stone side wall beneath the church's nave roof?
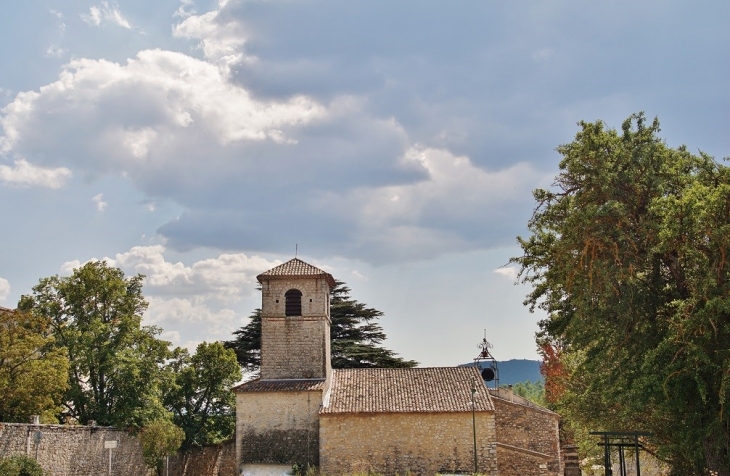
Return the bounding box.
[320,412,501,476]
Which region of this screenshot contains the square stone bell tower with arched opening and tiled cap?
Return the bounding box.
[256,258,335,380]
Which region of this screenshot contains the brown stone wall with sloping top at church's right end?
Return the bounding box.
[492,393,562,476]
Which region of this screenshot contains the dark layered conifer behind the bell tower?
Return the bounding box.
[225,281,418,370]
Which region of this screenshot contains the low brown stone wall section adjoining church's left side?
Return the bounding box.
[169,440,238,476]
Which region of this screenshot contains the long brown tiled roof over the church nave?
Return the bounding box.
[321,367,494,414]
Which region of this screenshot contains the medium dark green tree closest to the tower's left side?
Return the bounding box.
[163,342,241,449]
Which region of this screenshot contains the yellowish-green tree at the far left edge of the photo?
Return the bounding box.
[0,309,69,423]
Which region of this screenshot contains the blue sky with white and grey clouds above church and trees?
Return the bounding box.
[0,0,730,366]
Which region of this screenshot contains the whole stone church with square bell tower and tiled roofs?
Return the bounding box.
[234,258,563,476]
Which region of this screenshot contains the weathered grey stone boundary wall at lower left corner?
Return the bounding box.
[0,423,147,476]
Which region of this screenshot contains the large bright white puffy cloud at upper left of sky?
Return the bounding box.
[0,50,327,165]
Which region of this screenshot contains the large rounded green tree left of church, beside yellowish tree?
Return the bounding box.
[18,261,169,427]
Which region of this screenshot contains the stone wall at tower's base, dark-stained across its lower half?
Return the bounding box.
[236,391,322,466]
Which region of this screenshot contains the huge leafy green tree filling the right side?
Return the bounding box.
[512,114,730,476]
